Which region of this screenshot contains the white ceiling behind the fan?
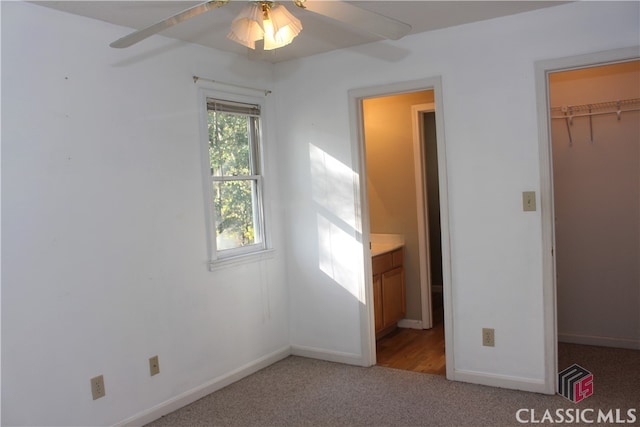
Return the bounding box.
[34,0,566,62]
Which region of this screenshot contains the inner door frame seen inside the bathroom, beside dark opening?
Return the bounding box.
[411,102,436,329]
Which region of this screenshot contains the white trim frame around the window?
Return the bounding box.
[198,85,275,271]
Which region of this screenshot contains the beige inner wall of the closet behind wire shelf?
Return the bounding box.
[549,61,640,349]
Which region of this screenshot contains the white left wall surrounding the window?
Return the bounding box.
[2,2,289,425]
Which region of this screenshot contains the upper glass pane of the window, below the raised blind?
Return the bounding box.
[208,110,253,176]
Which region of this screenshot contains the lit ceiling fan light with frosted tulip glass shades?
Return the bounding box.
[227,1,302,50]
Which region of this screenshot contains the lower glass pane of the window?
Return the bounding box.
[213,180,260,250]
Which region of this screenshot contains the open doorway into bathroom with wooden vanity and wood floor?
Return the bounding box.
[362,85,445,375]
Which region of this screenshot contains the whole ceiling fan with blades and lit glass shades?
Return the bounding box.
[110,0,411,50]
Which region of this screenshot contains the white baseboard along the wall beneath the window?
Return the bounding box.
[115,346,291,427]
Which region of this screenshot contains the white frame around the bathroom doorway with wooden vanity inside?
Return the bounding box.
[348,76,455,379]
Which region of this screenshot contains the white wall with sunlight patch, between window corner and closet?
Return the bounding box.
[276,2,639,390]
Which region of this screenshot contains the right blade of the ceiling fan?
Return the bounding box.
[295,0,411,40]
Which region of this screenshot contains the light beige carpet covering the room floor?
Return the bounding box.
[148,344,640,427]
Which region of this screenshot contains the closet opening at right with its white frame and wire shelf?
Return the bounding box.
[536,47,640,394]
